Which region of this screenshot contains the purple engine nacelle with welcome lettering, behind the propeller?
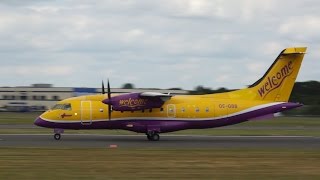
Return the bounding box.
[102,93,164,111]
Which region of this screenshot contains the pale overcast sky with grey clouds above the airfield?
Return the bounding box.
[0,0,320,89]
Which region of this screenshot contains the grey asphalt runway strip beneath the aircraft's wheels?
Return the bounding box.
[0,134,320,150]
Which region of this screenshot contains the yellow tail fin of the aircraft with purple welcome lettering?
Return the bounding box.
[242,47,307,102]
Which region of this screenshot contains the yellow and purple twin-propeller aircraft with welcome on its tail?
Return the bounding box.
[35,47,307,141]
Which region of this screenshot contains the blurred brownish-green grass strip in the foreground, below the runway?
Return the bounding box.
[0,148,320,180]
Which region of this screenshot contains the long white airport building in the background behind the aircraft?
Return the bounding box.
[0,84,189,112]
